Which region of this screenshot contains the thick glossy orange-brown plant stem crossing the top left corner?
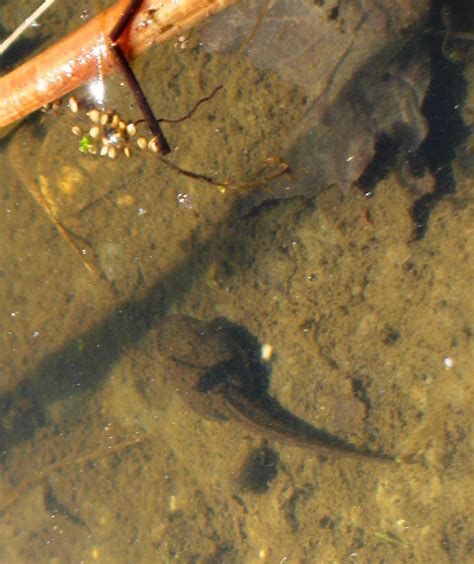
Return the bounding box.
[0,0,236,127]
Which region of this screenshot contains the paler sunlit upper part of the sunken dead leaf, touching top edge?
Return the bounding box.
[201,0,431,101]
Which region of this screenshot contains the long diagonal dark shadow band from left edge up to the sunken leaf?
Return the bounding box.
[0,196,248,455]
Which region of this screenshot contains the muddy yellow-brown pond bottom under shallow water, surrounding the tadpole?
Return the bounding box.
[0,2,474,562]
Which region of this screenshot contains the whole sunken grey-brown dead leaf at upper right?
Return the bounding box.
[203,0,431,203]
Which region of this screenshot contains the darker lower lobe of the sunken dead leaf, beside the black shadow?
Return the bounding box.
[276,43,430,200]
